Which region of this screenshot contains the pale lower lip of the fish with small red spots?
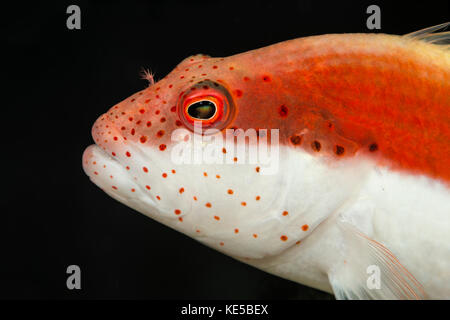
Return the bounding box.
[82,144,156,211]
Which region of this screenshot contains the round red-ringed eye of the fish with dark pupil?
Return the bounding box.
[177,80,235,132]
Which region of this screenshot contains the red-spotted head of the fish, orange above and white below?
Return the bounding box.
[83,55,366,259]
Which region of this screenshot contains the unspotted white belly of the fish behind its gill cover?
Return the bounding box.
[246,168,450,299]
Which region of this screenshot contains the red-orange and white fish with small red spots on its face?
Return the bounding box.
[82,23,450,299]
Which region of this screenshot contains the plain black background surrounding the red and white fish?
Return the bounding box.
[0,0,449,299]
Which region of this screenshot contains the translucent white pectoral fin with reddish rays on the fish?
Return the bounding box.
[328,221,426,300]
